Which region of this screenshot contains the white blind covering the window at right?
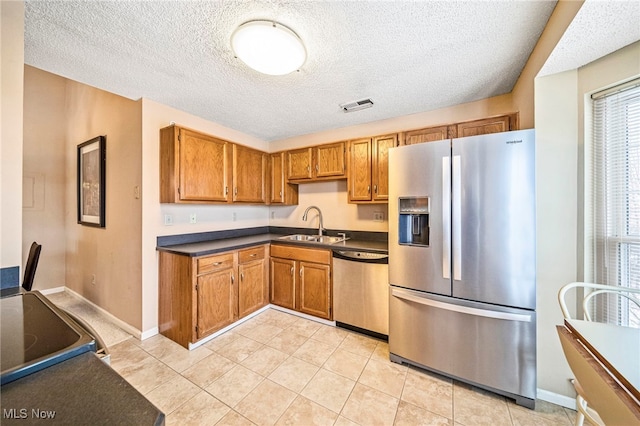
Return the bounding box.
[591,81,640,327]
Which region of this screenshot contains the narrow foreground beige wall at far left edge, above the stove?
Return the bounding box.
[0,1,24,282]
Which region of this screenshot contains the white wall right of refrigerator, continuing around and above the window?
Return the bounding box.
[535,42,640,405]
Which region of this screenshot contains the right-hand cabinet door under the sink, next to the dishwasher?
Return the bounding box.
[296,262,331,320]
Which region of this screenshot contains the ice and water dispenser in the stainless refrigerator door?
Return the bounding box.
[398,197,429,246]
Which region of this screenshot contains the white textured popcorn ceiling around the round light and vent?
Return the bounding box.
[20,0,637,141]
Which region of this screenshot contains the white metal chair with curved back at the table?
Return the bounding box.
[558,282,640,426]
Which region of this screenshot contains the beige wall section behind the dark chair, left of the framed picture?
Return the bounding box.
[22,66,67,290]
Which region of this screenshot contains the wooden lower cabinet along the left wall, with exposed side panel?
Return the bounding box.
[158,245,269,348]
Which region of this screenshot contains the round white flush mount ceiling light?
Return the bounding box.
[231,21,307,75]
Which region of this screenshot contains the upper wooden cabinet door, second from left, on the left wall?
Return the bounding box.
[233,144,267,203]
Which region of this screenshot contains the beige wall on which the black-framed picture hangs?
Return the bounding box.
[64,80,142,329]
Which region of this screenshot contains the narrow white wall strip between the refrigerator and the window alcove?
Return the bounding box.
[535,70,578,402]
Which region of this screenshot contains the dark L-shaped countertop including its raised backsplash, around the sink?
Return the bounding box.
[157,227,388,257]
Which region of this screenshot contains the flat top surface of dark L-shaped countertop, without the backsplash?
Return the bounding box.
[157,228,388,257]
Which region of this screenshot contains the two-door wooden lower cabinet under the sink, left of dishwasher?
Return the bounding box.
[270,245,333,320]
